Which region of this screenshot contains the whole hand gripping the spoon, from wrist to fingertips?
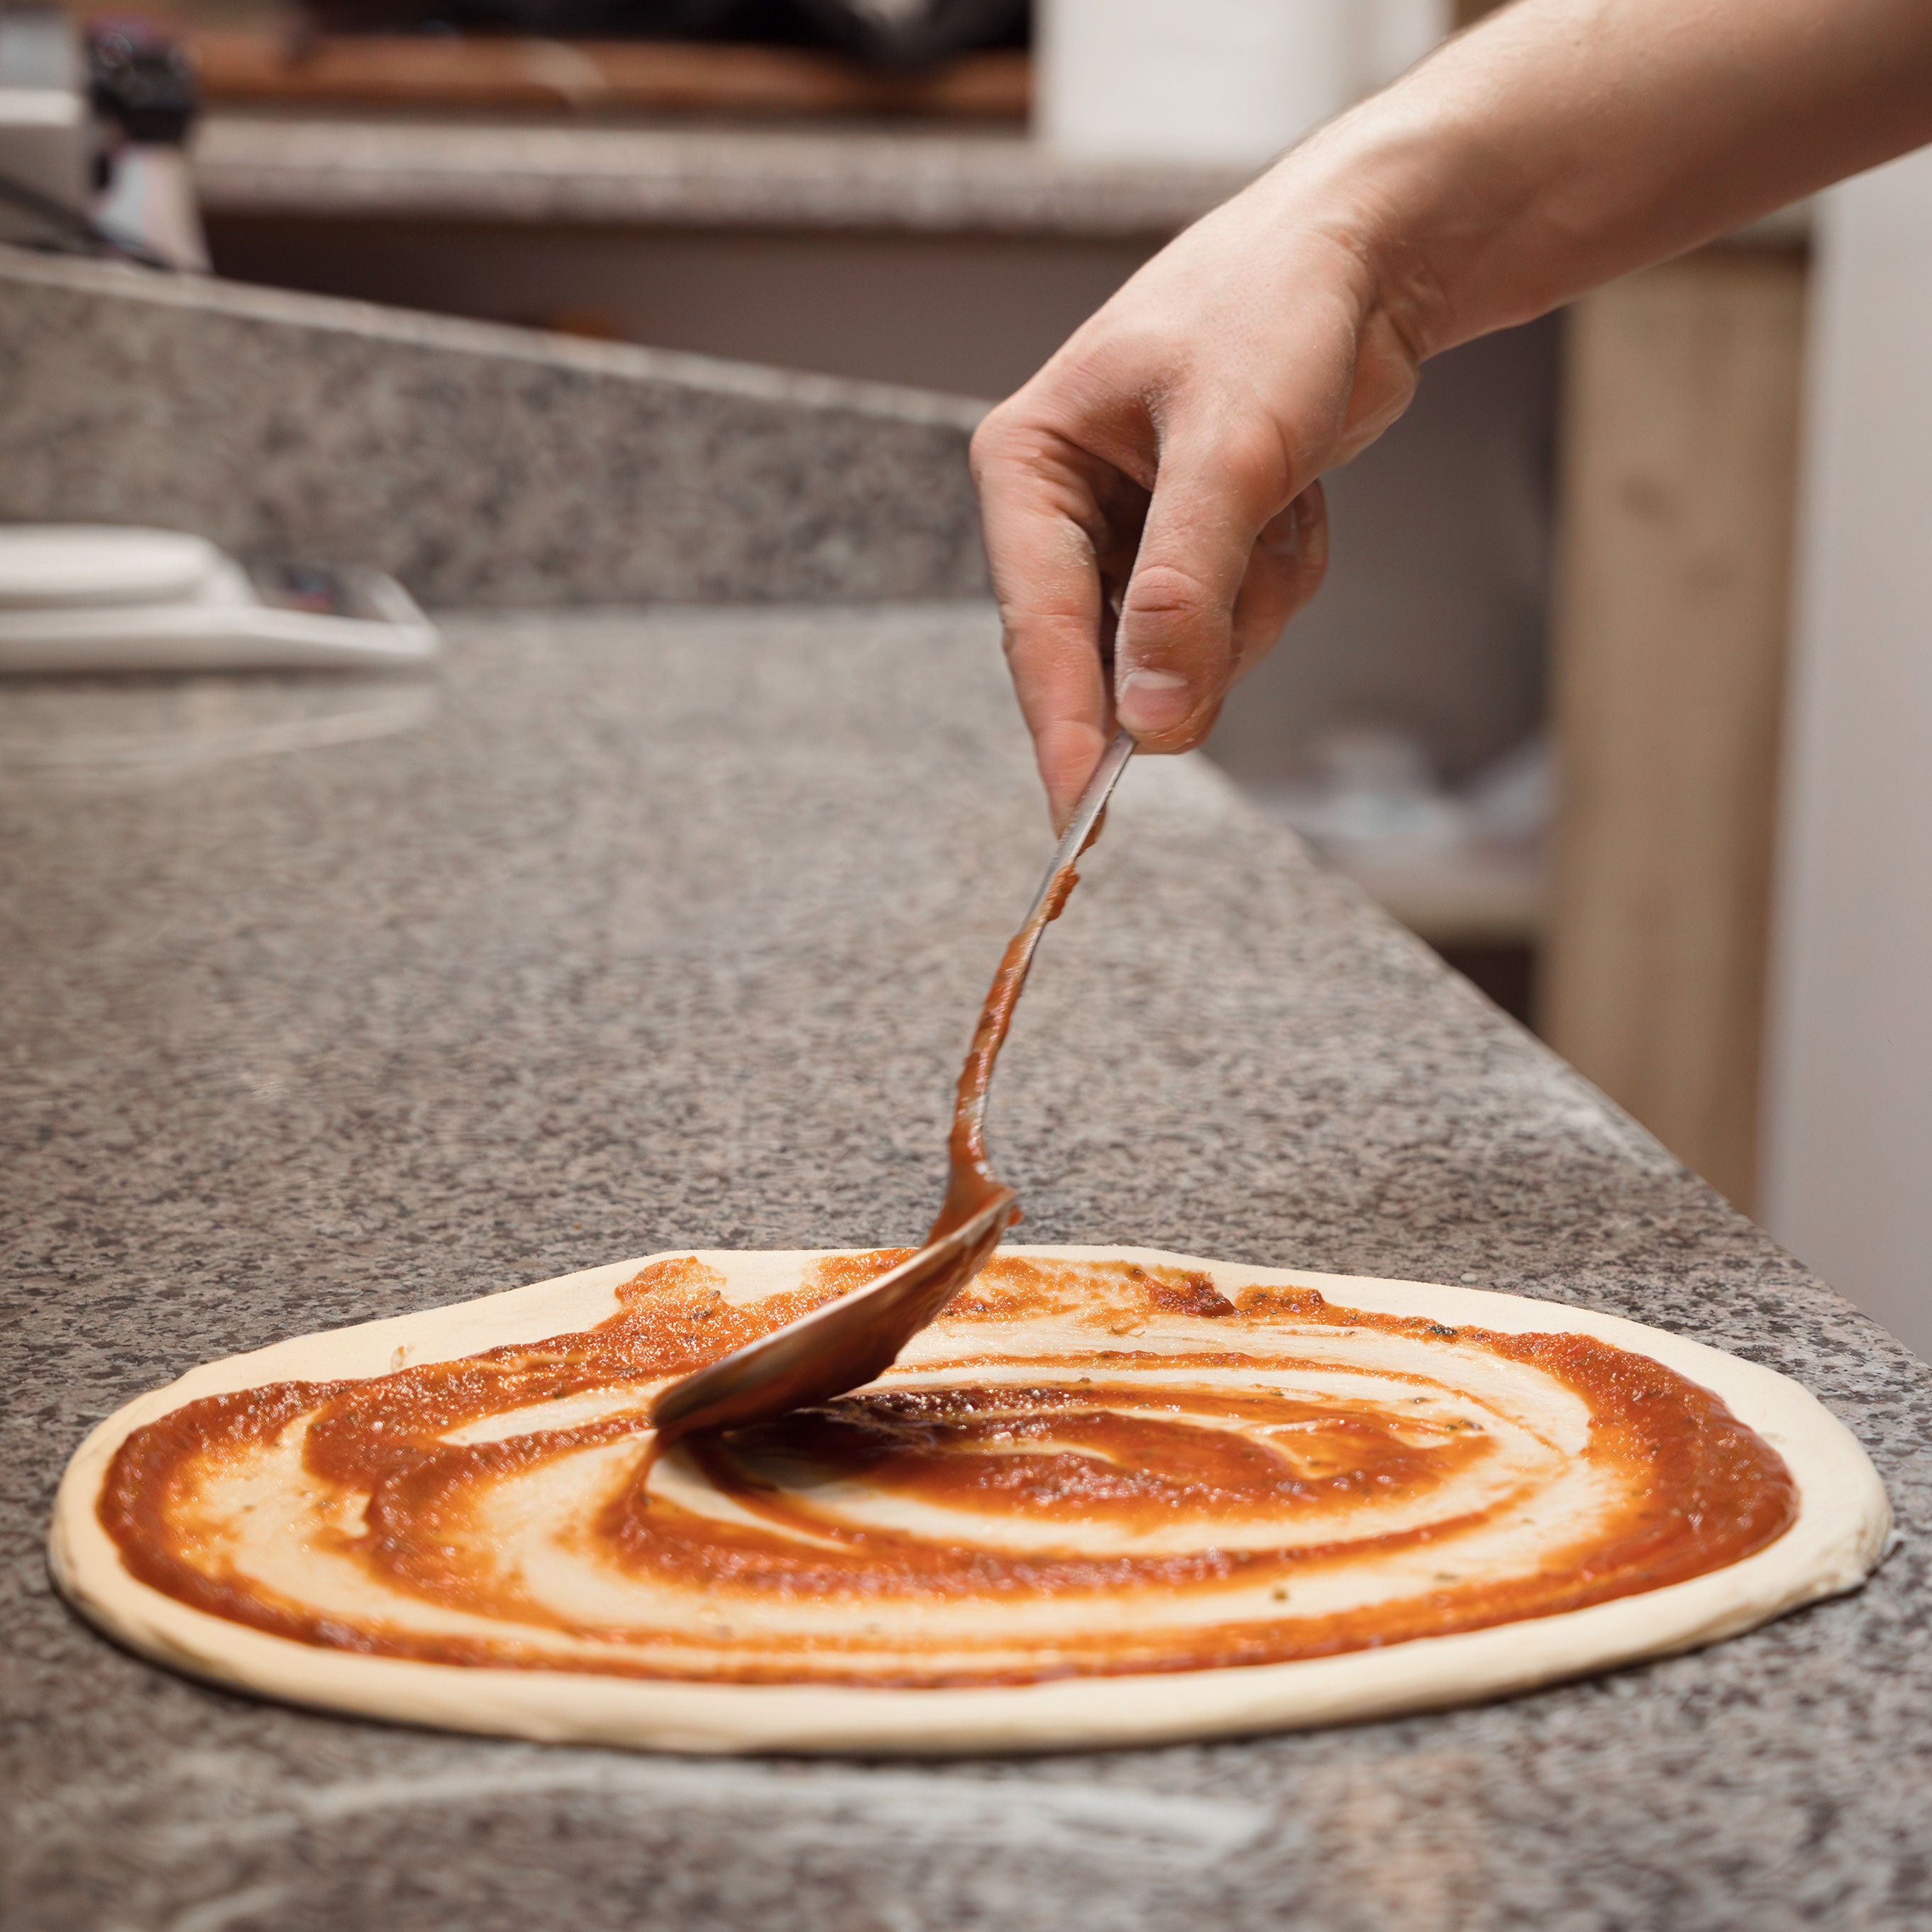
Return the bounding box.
[972,157,1420,827]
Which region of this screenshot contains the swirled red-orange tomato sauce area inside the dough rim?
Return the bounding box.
[99,1250,1796,1687]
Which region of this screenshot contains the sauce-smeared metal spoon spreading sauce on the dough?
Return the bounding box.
[651,732,1134,1447]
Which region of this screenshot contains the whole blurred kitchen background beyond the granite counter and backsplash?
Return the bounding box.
[0,0,1932,1349]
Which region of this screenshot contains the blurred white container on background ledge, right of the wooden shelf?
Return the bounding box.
[1036,0,1362,164]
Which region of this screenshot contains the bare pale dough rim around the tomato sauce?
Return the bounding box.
[48,1246,1892,1756]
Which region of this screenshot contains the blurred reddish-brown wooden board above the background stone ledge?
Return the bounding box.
[185,29,1032,122]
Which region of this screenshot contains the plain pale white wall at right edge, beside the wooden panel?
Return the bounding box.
[1764,149,1932,1357]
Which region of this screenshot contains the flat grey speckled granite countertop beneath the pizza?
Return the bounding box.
[0,607,1932,1932]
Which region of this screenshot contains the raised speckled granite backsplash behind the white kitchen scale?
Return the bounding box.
[0,248,986,607]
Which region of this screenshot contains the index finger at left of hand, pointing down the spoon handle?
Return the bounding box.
[973,417,1115,831]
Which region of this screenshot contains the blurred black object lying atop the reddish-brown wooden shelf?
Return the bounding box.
[304,0,1028,67]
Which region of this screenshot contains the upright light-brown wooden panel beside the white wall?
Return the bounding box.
[1540,249,1804,1210]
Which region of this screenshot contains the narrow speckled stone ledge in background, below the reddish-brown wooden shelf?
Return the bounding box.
[195,110,1254,236]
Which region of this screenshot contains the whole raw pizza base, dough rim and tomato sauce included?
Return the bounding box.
[50,1248,1889,1754]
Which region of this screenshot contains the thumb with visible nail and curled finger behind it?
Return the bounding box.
[1115,426,1327,751]
